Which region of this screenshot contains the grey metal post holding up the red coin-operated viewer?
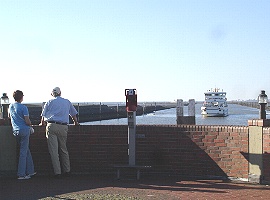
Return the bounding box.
[128,111,136,165]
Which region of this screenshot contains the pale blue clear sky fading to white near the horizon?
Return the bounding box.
[0,0,270,103]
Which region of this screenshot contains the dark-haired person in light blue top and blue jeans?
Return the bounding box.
[8,90,36,180]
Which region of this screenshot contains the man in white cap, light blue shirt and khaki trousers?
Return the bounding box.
[39,87,79,178]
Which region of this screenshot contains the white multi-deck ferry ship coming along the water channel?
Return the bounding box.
[201,88,228,117]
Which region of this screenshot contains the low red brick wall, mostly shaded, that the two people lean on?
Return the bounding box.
[30,125,249,178]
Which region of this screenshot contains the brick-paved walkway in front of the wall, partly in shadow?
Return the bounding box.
[0,175,270,200]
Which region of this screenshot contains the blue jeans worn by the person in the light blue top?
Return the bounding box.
[14,129,35,176]
